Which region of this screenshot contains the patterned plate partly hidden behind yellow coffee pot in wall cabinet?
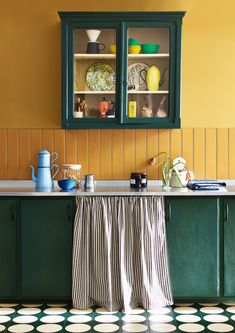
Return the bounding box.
[128,62,149,90]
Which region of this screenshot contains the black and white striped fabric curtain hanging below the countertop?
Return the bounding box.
[72,196,173,311]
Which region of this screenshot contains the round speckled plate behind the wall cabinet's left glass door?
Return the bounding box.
[86,62,116,91]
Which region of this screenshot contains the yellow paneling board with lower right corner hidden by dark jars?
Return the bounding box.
[123,129,135,179]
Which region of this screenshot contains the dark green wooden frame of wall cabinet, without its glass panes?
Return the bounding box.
[59,11,185,129]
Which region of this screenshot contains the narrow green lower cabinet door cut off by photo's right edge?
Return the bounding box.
[223,197,235,297]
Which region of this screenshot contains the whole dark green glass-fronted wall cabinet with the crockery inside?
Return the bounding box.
[59,12,185,128]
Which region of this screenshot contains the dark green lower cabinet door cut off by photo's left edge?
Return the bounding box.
[0,198,17,299]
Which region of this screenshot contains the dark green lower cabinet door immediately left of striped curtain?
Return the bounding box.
[21,198,73,299]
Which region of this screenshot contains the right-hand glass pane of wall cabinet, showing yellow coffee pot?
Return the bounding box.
[126,27,170,119]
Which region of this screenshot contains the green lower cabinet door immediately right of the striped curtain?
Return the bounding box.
[166,197,219,298]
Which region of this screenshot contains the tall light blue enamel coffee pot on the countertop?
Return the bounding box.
[30,149,59,190]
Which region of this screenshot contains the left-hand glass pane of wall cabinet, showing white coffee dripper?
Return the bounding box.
[73,28,116,118]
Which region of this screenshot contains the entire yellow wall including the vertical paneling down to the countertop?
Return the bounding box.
[0,0,235,179]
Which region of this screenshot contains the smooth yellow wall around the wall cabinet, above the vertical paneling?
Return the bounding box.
[0,0,235,128]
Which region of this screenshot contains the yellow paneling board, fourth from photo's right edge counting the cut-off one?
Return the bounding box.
[194,128,205,179]
